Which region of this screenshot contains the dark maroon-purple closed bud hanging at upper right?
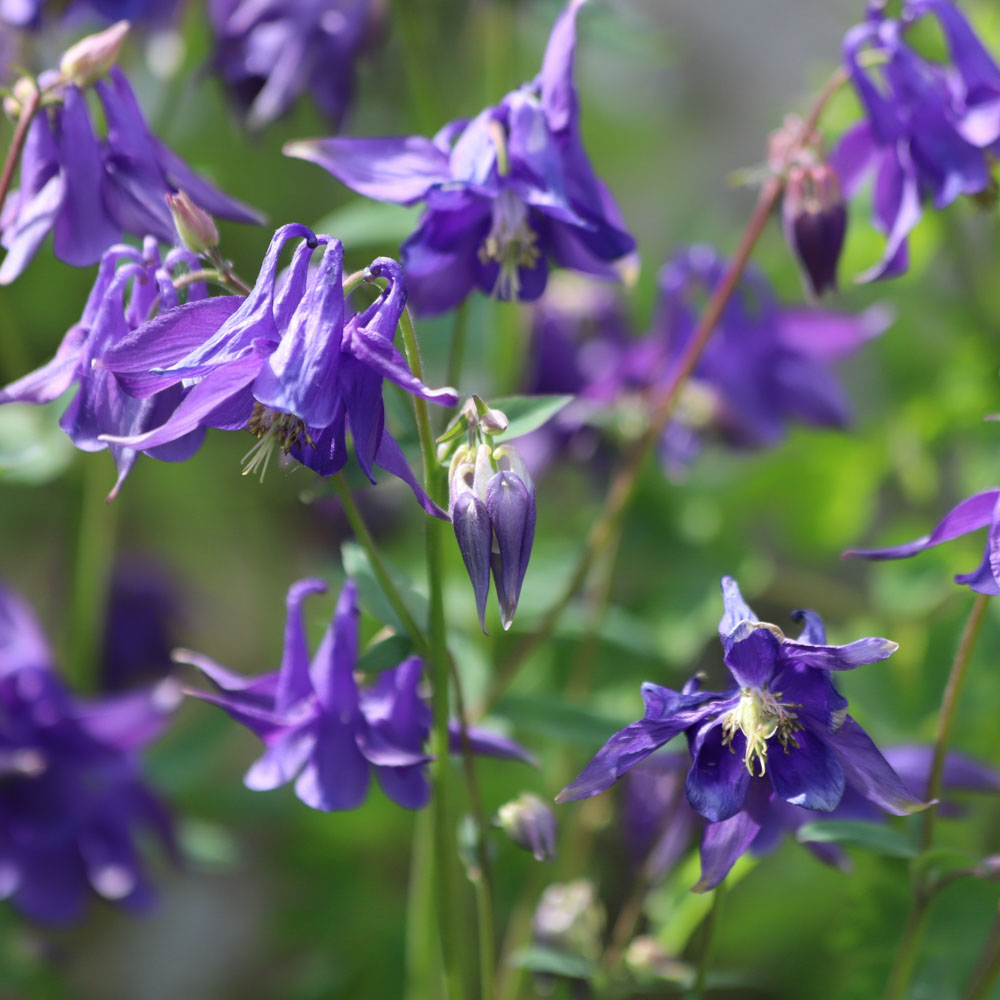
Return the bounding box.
[782,163,847,296]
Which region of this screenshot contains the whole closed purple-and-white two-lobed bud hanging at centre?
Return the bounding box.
[448,434,537,632]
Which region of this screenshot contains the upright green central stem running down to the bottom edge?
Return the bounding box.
[399,309,466,1000]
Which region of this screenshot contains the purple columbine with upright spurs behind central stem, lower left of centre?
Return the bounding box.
[184,579,530,812]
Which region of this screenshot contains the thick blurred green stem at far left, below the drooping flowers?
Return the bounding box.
[67,455,117,690]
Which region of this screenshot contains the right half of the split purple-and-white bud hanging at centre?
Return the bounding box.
[486,445,536,629]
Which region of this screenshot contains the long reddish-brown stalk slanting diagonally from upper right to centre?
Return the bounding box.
[482,62,849,711]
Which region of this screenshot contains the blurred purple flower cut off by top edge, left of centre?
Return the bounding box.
[209,0,379,128]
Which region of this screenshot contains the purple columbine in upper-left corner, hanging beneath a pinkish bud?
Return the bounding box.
[0,67,262,284]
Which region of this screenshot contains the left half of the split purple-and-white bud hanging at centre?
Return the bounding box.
[448,444,493,633]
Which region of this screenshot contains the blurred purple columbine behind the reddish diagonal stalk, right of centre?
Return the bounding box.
[630,246,890,472]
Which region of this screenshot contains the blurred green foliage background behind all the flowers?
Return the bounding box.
[0,0,1000,1000]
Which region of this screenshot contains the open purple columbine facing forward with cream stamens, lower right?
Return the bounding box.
[557,577,924,870]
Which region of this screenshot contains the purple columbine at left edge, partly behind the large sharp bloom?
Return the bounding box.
[0,237,216,499]
